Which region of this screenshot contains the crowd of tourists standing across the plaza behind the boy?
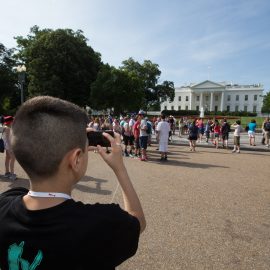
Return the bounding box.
[0,110,270,180]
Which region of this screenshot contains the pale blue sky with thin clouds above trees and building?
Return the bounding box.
[0,0,270,91]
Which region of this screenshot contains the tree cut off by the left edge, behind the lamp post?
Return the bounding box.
[0,43,20,114]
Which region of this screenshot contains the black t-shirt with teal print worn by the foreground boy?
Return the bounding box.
[0,188,140,270]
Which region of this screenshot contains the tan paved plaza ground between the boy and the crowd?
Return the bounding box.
[0,136,270,270]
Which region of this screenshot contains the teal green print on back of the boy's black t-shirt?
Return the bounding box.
[8,242,43,270]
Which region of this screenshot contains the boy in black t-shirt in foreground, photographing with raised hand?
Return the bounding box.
[0,97,145,270]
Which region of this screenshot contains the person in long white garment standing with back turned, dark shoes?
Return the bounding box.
[157,115,171,161]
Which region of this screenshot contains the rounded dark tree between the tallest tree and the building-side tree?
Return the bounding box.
[90,64,144,114]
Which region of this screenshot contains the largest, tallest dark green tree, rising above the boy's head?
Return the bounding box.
[16,26,101,106]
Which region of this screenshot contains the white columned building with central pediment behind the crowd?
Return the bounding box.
[161,80,264,114]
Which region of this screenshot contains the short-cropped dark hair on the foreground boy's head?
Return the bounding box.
[11,96,88,178]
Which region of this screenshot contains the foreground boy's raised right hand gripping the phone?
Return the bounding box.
[97,132,125,172]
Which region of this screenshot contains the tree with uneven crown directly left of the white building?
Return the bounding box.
[120,58,175,109]
